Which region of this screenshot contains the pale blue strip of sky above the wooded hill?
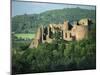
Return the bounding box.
[12,1,95,16]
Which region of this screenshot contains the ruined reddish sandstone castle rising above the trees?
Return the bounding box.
[29,18,91,48]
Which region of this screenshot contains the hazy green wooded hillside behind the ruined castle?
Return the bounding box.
[12,8,96,33]
